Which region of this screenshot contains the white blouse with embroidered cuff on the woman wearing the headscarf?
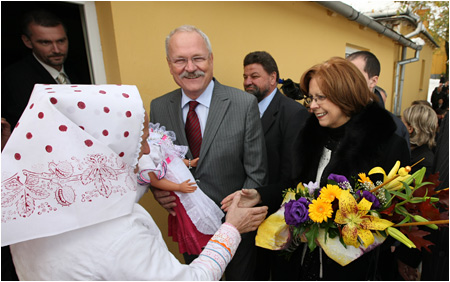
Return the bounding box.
[11,204,241,281]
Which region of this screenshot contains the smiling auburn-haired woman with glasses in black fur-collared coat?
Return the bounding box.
[223,57,410,280]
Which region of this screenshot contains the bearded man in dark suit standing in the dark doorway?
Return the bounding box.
[2,10,78,129]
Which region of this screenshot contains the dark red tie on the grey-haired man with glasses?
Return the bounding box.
[184,101,202,159]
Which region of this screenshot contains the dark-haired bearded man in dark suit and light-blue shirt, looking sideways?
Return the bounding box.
[244,51,310,281]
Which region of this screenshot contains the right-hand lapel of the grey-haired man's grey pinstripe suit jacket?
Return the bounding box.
[199,80,230,166]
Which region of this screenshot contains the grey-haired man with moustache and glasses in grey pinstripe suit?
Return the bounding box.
[150,26,267,280]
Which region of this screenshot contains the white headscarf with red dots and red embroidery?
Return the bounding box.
[1,85,145,246]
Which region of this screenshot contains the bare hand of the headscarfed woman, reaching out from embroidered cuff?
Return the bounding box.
[225,193,268,234]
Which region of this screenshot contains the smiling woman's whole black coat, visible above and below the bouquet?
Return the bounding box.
[295,103,410,280]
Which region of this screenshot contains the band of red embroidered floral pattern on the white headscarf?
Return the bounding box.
[2,154,136,222]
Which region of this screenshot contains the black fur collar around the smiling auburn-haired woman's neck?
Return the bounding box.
[296,103,396,185]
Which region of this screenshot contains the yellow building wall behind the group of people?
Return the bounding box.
[96,1,431,258]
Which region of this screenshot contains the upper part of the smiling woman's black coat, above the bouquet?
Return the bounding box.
[294,103,410,186]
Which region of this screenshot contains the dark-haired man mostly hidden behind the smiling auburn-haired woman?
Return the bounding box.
[347,51,409,148]
